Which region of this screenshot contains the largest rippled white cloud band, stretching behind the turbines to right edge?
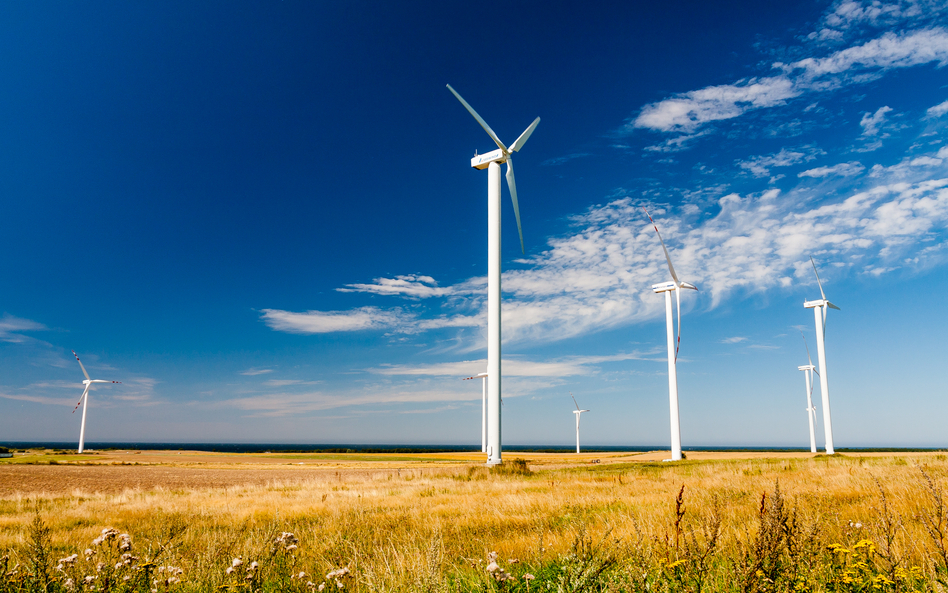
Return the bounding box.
[265,140,948,344]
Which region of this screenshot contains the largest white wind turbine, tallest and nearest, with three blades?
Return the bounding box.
[447,84,540,465]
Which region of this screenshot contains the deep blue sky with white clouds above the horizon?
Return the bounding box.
[0,1,948,448]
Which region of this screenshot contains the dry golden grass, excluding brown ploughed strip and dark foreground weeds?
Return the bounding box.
[0,454,948,591]
